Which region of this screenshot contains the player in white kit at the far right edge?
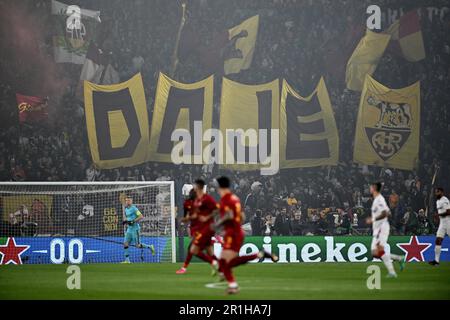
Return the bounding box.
[429,188,450,266]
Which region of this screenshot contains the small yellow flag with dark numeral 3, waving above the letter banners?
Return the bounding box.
[224,15,259,74]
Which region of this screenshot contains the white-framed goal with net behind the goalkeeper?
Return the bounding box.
[0,181,176,263]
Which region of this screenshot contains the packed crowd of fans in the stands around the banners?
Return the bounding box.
[0,0,450,236]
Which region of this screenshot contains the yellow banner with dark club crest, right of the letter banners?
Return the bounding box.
[353,76,420,170]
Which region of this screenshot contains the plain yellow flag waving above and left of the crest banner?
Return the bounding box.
[345,29,391,91]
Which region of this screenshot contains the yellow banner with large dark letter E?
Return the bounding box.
[280,78,339,168]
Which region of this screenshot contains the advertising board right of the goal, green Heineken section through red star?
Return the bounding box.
[184,236,450,263]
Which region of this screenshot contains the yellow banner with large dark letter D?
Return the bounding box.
[84,74,149,169]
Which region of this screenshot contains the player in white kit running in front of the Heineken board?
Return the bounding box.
[366,182,405,278]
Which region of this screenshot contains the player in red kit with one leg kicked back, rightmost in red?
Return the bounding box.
[213,177,278,294]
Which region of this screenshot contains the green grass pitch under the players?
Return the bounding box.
[0,263,450,299]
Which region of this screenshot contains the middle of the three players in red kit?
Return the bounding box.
[190,179,218,270]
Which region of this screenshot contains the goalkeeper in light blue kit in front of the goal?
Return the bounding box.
[122,197,155,263]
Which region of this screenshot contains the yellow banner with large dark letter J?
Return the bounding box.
[218,78,279,171]
